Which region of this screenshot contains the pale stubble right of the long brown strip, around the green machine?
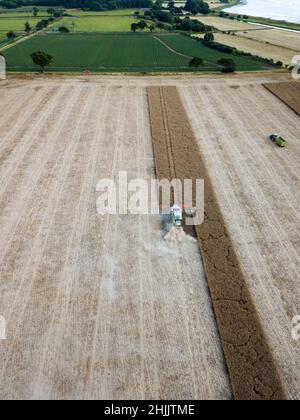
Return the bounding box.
[180,79,300,399]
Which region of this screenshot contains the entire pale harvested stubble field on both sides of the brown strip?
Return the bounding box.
[0,75,300,399]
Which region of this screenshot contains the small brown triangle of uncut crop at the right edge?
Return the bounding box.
[264,82,300,116]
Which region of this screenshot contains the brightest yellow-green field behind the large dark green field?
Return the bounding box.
[52,15,137,32]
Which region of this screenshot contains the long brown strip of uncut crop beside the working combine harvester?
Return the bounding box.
[148,86,286,400]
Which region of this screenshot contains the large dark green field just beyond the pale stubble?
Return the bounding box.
[5,33,270,72]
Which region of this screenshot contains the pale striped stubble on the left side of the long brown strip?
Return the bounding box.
[0,79,232,399]
